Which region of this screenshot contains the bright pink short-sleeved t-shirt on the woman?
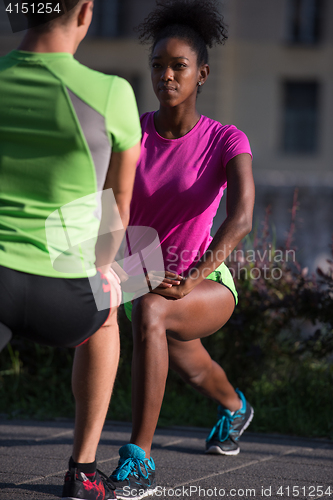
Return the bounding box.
[130,112,252,275]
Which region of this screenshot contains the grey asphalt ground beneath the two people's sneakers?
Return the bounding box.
[0,420,333,500]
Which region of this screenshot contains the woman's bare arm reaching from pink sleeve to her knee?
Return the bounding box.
[154,153,255,299]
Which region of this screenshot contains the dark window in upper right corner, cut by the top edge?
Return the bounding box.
[287,0,323,45]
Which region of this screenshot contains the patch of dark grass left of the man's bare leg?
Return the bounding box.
[0,341,74,420]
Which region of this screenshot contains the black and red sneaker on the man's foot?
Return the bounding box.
[62,468,117,500]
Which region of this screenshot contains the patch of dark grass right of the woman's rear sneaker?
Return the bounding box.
[249,363,333,439]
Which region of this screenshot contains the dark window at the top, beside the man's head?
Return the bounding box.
[89,0,122,38]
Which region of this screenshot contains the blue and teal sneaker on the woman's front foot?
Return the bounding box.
[110,444,157,500]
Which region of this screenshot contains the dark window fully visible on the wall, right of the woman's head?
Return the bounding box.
[283,82,319,154]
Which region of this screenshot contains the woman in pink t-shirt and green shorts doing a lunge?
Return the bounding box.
[111,0,254,498]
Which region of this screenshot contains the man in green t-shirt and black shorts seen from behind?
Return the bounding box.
[0,0,141,500]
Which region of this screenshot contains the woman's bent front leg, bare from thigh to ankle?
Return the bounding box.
[131,280,235,457]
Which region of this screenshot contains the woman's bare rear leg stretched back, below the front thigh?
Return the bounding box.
[168,338,241,411]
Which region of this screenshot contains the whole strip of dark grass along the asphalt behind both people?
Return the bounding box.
[0,338,333,439]
